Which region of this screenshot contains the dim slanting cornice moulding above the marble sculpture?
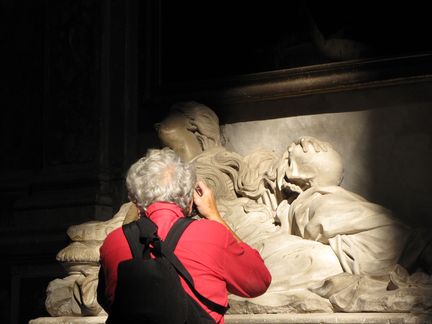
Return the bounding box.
[160,54,432,104]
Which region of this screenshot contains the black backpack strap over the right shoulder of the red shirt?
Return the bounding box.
[162,217,229,315]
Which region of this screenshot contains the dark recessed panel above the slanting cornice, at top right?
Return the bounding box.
[160,1,432,84]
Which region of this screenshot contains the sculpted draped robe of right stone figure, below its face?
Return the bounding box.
[288,186,411,275]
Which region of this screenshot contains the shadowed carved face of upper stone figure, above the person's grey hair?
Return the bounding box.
[156,113,202,162]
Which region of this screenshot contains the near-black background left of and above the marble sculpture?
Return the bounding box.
[0,0,432,323]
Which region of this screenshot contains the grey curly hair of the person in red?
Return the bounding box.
[126,147,196,215]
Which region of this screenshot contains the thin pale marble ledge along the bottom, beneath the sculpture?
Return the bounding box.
[29,313,432,324]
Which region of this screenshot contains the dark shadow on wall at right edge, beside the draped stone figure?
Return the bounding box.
[368,98,432,225]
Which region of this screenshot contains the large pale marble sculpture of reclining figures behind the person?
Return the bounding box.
[41,102,432,316]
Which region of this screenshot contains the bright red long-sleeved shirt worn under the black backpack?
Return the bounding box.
[100,202,271,323]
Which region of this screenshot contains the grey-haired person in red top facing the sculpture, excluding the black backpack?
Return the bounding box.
[100,148,271,323]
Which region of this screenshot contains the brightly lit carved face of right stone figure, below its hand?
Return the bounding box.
[285,143,343,191]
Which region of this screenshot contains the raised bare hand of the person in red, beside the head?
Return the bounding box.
[193,181,221,220]
